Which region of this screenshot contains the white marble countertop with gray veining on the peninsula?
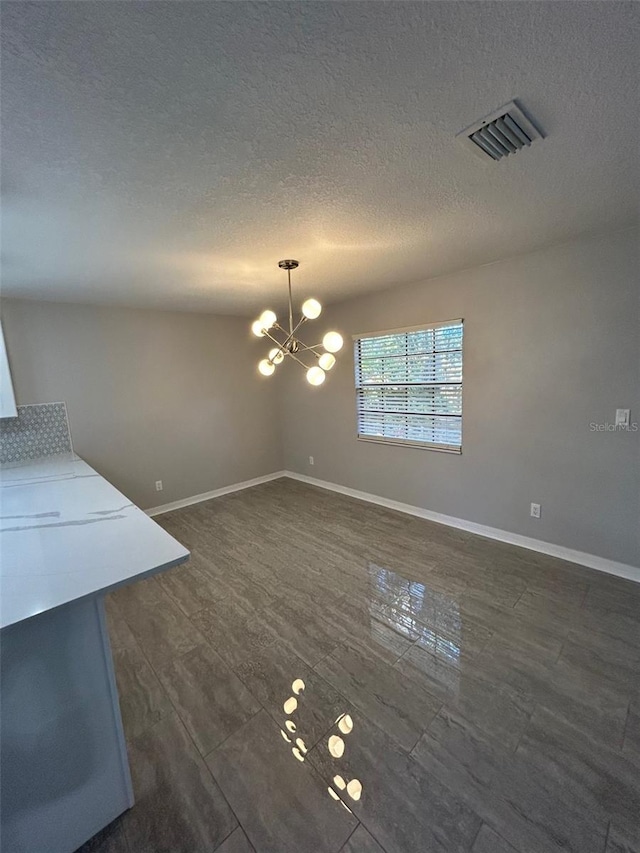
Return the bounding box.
[0,454,189,628]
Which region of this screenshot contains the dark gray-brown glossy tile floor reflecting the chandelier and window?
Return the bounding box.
[83,480,640,853]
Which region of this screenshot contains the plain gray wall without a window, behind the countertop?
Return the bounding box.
[2,299,282,508]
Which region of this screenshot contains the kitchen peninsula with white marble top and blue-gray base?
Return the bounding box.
[0,453,189,853]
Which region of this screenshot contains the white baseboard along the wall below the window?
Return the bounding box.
[282,471,640,583]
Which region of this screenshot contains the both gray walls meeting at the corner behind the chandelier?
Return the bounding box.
[2,225,640,565]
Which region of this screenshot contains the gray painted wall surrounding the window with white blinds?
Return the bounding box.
[281,230,640,565]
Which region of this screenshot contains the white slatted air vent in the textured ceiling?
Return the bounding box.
[456,101,544,160]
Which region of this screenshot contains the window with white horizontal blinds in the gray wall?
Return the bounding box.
[354,320,462,453]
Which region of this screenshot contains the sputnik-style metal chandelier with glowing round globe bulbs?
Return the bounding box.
[251,261,343,385]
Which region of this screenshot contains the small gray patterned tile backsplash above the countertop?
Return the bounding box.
[0,403,73,463]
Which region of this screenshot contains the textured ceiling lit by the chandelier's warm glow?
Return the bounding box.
[1,0,640,313]
